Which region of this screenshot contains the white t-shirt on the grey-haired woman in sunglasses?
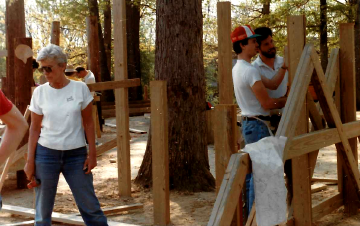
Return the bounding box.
[29,80,93,151]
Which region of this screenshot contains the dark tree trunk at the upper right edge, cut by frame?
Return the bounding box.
[354,0,360,111]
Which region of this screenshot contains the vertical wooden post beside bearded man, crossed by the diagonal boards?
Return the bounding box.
[288,15,312,226]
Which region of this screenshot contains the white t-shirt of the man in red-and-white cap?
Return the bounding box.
[232,60,270,116]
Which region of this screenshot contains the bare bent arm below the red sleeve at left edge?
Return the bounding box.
[0,105,28,164]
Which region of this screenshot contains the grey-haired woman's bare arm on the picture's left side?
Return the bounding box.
[24,112,44,180]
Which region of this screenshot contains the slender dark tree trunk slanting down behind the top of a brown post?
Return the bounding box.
[88,0,115,101]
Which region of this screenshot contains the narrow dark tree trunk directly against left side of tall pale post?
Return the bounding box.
[104,0,111,77]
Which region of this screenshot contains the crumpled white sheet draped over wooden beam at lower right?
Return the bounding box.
[243,137,287,226]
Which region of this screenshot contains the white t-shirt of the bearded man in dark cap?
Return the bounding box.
[252,56,288,98]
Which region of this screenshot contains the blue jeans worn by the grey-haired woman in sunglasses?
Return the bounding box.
[35,144,108,226]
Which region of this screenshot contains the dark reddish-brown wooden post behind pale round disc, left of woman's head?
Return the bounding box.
[13,38,33,114]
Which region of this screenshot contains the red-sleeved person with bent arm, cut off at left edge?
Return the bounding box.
[0,90,29,209]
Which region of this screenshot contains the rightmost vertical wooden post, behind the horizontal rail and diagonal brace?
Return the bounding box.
[340,23,358,215]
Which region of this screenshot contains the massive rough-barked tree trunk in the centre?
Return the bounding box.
[135,0,215,191]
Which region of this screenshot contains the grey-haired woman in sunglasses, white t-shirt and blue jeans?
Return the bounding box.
[24,44,108,226]
